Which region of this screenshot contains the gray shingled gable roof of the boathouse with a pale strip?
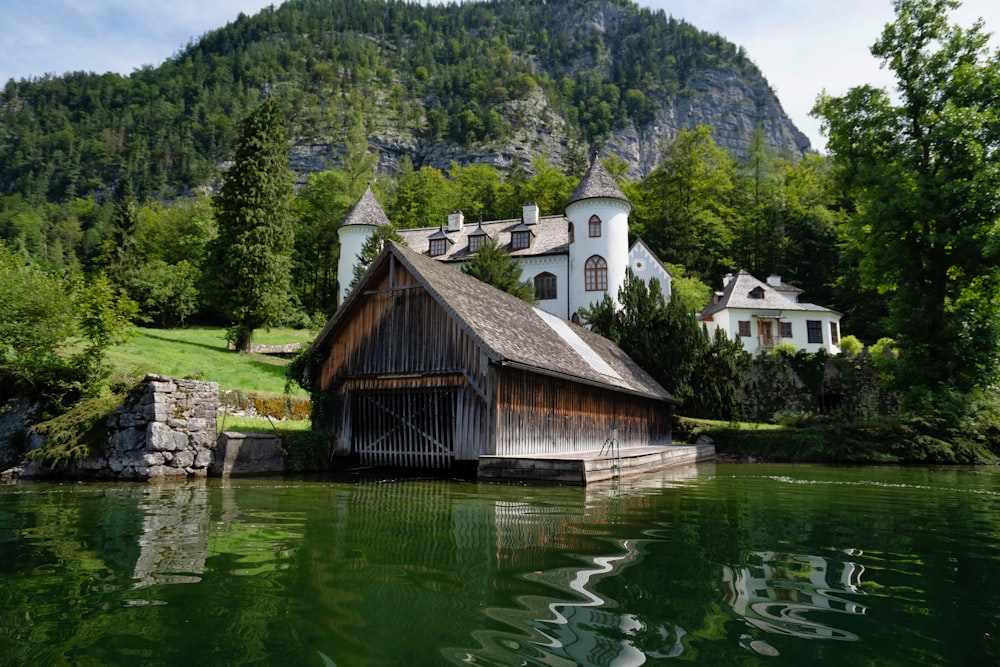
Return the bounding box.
[312,243,677,403]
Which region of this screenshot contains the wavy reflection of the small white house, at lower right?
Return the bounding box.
[722,551,867,641]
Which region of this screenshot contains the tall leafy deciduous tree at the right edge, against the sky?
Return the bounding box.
[814,0,1000,407]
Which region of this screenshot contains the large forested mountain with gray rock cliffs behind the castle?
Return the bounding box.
[0,0,809,202]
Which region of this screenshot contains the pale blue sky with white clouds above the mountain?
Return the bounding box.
[0,0,1000,150]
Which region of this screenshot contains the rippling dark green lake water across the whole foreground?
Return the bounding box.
[0,464,1000,667]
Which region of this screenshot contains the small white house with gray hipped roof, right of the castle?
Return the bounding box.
[698,271,840,354]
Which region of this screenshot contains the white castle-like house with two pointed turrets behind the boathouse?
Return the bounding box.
[337,160,671,321]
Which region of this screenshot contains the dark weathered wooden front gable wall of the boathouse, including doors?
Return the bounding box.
[320,259,494,467]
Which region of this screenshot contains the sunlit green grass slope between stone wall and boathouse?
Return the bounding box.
[109,327,316,396]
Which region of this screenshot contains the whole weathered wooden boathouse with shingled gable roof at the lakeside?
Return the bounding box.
[312,243,708,480]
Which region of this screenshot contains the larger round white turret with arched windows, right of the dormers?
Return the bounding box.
[565,160,632,318]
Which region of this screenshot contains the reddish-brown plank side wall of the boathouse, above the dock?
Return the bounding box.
[488,368,671,456]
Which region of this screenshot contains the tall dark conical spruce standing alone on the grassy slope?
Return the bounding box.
[210,98,294,353]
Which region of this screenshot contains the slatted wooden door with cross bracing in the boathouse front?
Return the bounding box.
[351,387,458,468]
